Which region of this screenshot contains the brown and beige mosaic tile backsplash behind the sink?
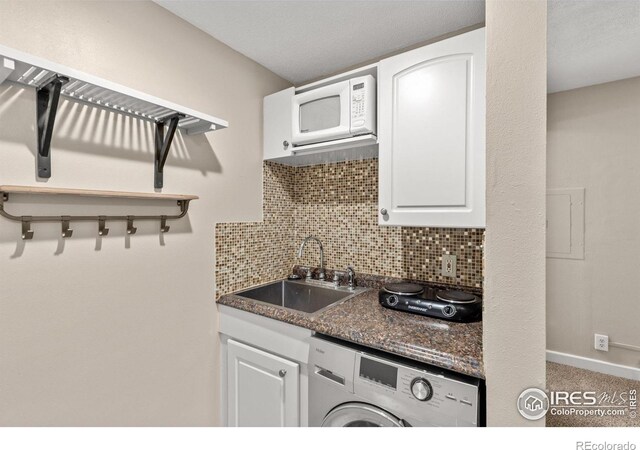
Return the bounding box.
[216,159,484,296]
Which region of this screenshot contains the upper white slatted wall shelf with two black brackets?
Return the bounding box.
[0,45,229,188]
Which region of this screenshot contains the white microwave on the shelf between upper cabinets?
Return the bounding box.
[291,75,376,146]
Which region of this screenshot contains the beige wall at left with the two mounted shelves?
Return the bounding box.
[0,1,287,426]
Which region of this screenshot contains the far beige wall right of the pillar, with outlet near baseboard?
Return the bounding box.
[547,77,640,368]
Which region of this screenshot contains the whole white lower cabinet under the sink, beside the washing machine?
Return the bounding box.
[218,305,311,427]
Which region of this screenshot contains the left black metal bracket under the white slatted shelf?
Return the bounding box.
[36,74,69,178]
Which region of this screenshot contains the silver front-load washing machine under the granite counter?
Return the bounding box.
[309,335,483,427]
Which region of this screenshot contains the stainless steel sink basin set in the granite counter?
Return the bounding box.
[235,280,366,315]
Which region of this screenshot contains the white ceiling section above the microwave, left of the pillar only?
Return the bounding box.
[155,0,484,84]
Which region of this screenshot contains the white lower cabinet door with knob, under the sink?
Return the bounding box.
[227,339,300,427]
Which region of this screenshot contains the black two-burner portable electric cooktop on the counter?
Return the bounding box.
[378,283,482,322]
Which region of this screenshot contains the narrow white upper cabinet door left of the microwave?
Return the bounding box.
[262,87,295,160]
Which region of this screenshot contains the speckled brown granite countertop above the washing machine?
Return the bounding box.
[218,289,484,378]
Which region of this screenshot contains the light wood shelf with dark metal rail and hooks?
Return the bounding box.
[0,186,198,240]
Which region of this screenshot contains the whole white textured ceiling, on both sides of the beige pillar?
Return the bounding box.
[155,0,640,92]
